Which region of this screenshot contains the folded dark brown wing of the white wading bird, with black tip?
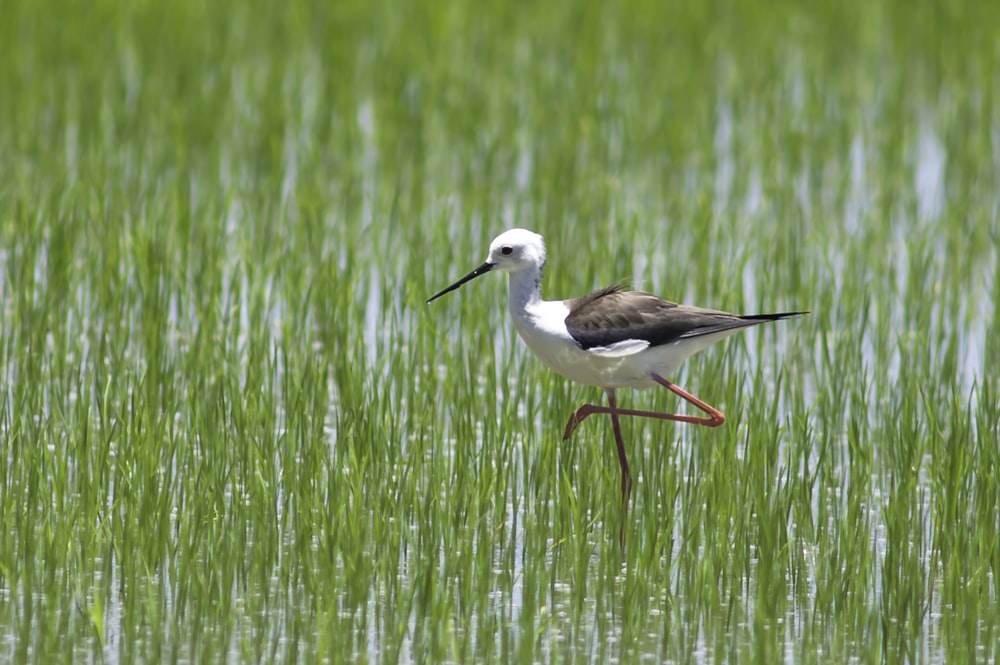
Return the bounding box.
[566,284,802,349]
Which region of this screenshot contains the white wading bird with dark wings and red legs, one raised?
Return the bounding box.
[427,228,808,512]
